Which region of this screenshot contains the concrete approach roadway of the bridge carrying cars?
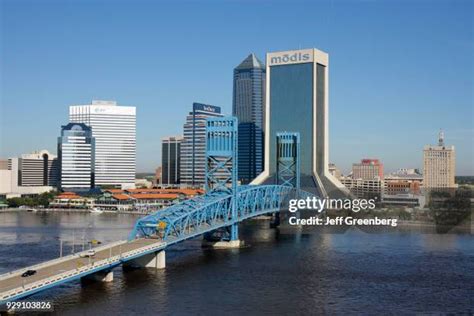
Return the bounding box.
[0,238,166,304]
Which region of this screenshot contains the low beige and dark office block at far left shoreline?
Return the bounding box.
[12,150,59,187]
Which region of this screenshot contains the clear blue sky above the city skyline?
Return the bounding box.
[0,0,474,175]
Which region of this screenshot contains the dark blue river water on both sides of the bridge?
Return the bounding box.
[0,212,474,316]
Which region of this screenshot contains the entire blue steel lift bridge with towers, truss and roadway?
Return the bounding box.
[0,117,311,305]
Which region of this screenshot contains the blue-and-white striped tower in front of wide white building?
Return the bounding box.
[58,123,95,191]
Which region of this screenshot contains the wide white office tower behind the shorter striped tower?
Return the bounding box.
[69,100,136,189]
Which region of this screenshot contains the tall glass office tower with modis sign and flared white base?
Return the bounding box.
[253,49,348,196]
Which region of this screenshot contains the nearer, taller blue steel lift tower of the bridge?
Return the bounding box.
[205,116,240,248]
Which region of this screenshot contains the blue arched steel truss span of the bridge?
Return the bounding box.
[129,185,293,245]
